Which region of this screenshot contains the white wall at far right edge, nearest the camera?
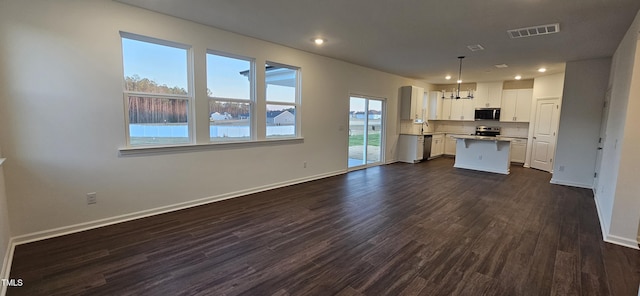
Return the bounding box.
[596,12,640,248]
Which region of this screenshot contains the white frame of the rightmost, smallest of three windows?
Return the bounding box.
[264,60,302,140]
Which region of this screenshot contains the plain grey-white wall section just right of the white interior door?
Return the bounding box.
[551,58,611,188]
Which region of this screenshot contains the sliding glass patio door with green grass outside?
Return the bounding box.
[348,96,385,169]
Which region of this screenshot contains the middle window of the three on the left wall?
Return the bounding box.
[207,52,255,142]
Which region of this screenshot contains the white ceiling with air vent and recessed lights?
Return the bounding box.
[118,0,640,83]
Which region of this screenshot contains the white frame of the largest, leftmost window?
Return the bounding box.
[120,31,195,149]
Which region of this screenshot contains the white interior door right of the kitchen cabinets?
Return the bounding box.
[531,98,560,172]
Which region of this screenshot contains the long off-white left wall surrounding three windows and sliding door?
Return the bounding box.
[0,0,429,235]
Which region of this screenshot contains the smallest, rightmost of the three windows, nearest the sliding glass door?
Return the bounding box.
[265,62,300,138]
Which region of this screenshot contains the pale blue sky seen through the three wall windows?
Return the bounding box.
[122,38,295,103]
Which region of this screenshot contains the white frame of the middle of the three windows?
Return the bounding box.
[205,49,257,144]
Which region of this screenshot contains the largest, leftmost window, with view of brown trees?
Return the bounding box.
[121,33,193,146]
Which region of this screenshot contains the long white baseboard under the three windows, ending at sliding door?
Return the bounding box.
[11,170,347,246]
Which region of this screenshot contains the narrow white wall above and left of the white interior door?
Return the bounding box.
[524,72,564,167]
